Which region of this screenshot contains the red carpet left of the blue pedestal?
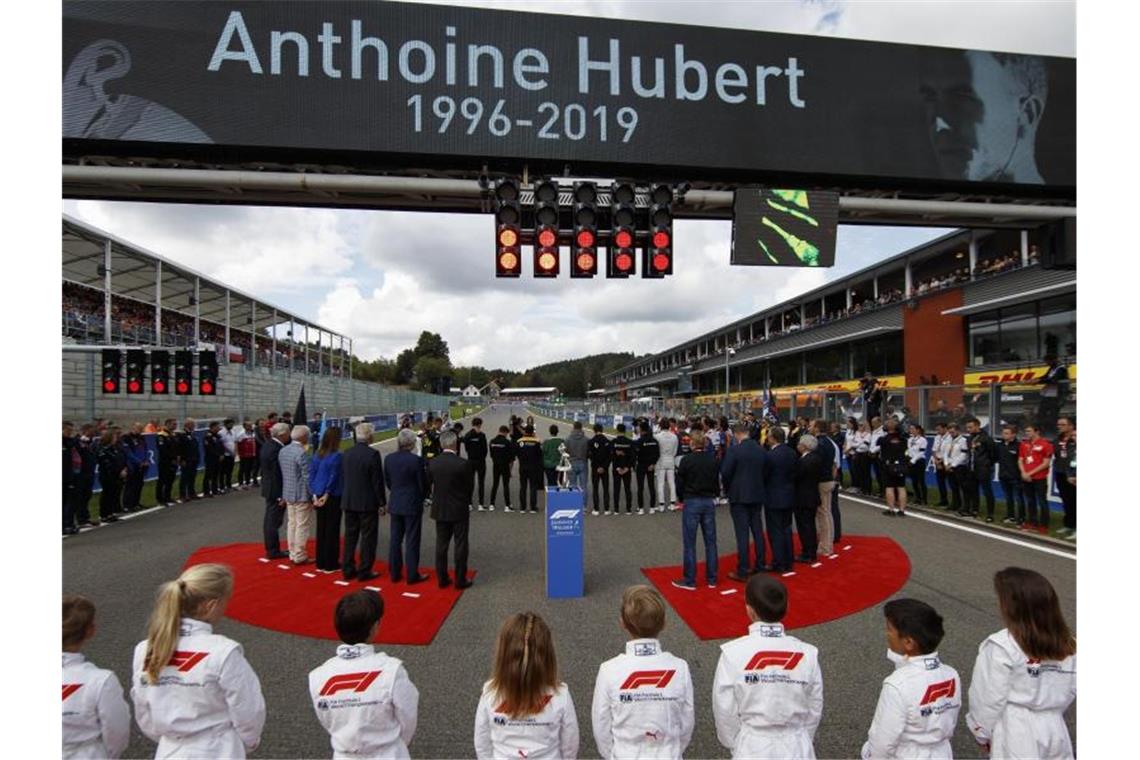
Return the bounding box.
[186,541,474,645]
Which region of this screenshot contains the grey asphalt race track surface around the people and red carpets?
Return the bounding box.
[63,407,1076,758]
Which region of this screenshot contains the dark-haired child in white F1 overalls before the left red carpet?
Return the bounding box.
[309,589,420,759]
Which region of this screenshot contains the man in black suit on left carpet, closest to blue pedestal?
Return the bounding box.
[428,431,475,589]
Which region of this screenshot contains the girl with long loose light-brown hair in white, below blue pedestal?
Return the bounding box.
[475,612,578,760]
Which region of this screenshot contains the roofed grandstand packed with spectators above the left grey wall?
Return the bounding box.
[63,214,352,377]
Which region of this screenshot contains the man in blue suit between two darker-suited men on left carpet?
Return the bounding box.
[384,428,428,586]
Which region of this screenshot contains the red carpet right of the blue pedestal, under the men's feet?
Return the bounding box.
[642,536,911,639]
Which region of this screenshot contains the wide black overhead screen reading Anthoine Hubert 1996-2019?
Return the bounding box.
[62,0,1076,191]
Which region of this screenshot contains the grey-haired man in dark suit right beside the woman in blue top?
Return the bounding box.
[341,423,388,581]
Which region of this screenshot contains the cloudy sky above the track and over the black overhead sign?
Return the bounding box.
[64,0,1076,369]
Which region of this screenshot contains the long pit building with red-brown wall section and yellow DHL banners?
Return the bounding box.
[604,229,1076,428]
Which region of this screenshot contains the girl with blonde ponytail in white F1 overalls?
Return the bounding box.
[131,564,266,758]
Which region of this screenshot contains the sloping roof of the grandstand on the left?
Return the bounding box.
[63,214,348,341]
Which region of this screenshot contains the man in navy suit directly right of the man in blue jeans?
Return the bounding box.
[720,422,772,583]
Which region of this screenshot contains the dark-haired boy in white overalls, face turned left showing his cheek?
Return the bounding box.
[863,599,962,760]
